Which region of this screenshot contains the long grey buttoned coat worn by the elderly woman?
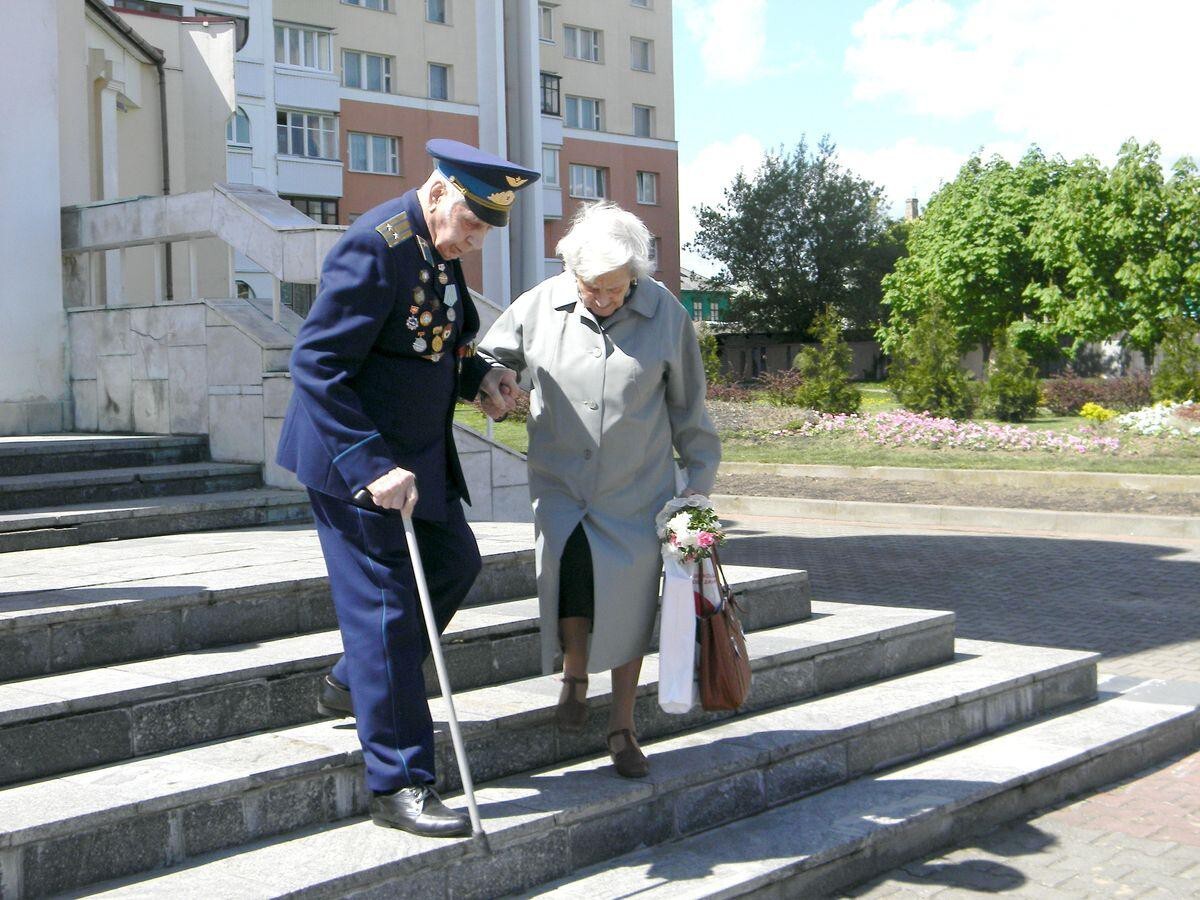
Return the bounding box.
[479,272,721,673]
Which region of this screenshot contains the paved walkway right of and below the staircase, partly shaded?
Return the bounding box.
[722,517,1200,900]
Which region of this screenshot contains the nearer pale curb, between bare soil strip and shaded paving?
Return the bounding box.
[712,494,1200,540]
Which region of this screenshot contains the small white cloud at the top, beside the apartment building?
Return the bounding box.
[676,0,767,83]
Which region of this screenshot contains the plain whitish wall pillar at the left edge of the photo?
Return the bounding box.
[0,0,68,434]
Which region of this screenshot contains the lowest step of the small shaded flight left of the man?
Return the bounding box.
[0,487,312,553]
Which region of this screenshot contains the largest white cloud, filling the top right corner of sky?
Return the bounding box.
[846,0,1200,160]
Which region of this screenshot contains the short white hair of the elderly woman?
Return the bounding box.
[557,200,653,281]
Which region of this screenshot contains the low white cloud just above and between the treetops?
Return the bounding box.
[838,138,1026,217]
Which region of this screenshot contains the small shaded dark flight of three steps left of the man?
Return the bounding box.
[0,434,311,552]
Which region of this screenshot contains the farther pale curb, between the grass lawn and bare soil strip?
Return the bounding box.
[718,462,1200,493]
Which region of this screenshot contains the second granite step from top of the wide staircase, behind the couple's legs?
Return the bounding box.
[0,566,811,785]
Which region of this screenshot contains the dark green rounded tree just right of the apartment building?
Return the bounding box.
[688,138,902,335]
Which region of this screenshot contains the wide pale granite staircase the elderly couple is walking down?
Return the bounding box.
[0,444,1200,900]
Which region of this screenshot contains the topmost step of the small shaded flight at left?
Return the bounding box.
[0,433,209,476]
